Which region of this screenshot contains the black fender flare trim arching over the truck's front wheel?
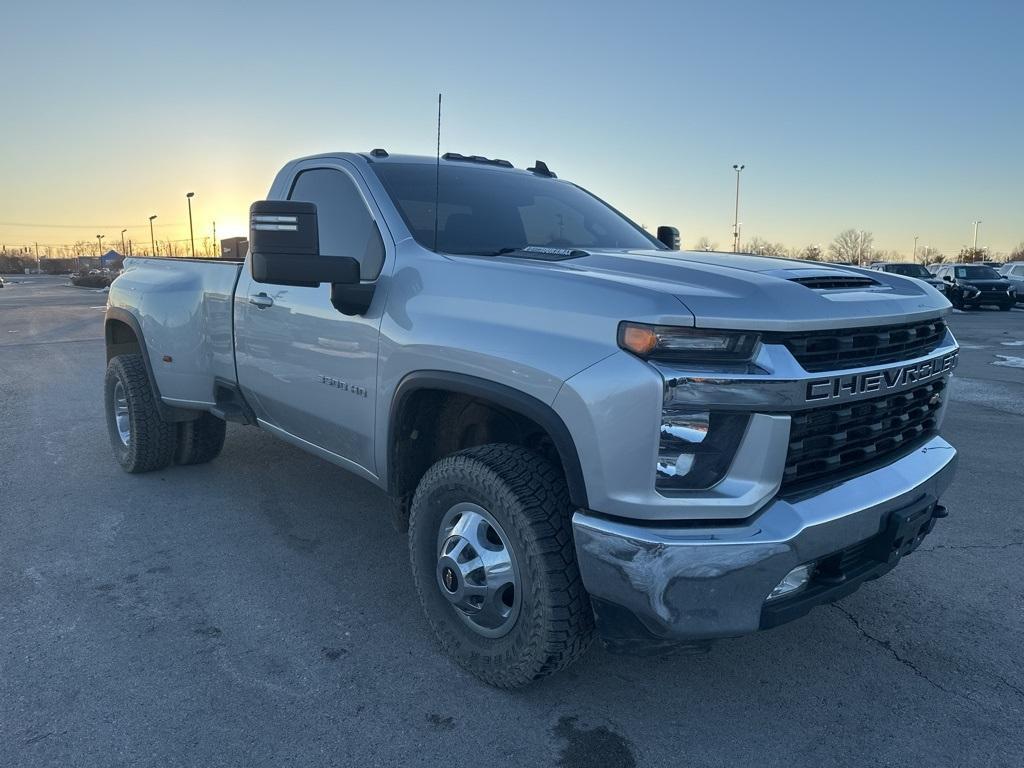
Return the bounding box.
[387,371,588,509]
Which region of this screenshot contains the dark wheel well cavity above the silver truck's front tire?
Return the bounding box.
[388,387,587,524]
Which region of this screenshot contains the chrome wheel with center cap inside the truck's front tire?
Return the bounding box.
[437,502,522,638]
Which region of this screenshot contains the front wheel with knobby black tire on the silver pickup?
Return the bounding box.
[409,444,594,688]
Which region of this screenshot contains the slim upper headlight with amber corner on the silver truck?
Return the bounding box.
[618,323,758,362]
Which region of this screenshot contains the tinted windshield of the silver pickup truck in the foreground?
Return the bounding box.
[373,163,664,254]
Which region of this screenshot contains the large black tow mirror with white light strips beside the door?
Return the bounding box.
[249,200,359,288]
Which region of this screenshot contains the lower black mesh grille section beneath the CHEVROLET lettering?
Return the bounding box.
[782,379,945,490]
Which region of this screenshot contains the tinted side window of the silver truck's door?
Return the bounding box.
[288,168,384,280]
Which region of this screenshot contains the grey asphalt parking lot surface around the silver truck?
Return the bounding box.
[0,278,1024,768]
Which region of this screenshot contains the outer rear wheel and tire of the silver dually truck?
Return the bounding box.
[103,354,177,474]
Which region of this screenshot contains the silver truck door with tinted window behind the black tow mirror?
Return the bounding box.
[234,160,390,475]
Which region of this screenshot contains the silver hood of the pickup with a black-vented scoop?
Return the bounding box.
[500,250,950,331]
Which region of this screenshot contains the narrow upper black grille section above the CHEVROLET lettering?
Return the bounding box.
[764,319,946,373]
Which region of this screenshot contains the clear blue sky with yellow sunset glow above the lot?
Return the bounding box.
[0,0,1024,259]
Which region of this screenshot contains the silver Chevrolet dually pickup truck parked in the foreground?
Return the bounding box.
[105,150,957,687]
